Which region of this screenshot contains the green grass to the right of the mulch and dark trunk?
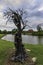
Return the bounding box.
[25,44,43,65]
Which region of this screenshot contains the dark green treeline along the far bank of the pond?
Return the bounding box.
[0,29,43,36]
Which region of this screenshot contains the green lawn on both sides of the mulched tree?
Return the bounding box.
[0,34,43,65]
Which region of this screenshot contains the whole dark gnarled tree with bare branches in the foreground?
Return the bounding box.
[4,8,27,62]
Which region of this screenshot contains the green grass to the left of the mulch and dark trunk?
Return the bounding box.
[0,40,13,65]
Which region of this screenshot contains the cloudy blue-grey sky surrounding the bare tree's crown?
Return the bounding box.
[0,0,43,28]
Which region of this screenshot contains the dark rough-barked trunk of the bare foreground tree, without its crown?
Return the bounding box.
[11,23,27,62]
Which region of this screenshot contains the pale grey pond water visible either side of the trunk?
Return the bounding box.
[2,34,43,44]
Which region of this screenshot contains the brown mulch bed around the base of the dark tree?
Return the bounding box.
[5,49,36,65]
